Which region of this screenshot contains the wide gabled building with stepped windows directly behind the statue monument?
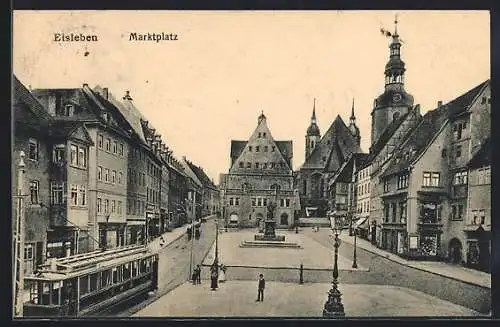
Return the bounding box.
[220,113,297,228]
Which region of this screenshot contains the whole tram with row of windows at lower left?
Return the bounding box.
[23,245,159,317]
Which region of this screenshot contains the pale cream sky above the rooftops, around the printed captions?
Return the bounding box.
[12,10,490,183]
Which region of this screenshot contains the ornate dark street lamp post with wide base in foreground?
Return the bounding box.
[323,217,345,318]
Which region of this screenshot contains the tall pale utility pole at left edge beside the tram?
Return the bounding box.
[12,151,25,317]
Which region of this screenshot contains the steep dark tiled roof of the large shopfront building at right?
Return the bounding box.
[383,81,487,176]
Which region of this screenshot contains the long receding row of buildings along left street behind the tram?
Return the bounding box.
[12,77,220,274]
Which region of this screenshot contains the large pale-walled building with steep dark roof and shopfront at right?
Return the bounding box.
[380,82,489,263]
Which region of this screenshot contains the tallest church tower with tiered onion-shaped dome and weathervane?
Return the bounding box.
[371,16,413,145]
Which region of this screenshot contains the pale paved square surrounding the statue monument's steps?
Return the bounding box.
[203,230,367,270]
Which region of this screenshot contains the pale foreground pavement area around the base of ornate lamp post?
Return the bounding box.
[134,281,485,317]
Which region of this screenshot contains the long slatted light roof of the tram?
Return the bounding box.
[26,245,154,280]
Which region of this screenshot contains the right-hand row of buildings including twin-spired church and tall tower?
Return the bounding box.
[295,20,491,270]
